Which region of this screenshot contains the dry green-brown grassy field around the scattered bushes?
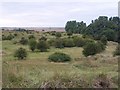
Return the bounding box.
[2,32,119,88]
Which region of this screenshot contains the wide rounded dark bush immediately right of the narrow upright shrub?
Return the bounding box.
[37,40,49,52]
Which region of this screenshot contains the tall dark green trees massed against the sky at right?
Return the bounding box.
[65,16,120,43]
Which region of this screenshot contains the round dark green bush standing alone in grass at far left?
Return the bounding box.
[14,48,27,60]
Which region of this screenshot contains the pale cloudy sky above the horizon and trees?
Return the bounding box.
[0,0,118,27]
